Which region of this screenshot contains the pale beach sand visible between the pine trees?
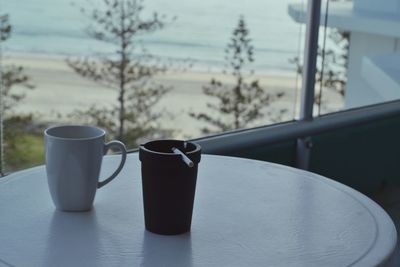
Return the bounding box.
[3,54,343,138]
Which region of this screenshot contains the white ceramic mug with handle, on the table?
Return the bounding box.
[44,125,127,211]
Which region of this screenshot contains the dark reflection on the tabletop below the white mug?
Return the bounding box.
[44,209,101,266]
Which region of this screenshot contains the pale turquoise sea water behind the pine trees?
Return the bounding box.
[0,0,304,72]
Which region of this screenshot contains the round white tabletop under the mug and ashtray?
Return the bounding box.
[0,154,397,266]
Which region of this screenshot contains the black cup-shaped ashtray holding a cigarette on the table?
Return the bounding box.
[139,140,201,235]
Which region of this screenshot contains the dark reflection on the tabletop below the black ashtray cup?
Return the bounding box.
[141,230,193,266]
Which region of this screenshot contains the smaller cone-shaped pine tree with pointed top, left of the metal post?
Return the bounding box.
[189,17,283,133]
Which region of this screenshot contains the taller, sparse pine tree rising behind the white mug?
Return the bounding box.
[67,0,171,145]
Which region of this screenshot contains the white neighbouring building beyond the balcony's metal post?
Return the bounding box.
[288,0,400,108]
